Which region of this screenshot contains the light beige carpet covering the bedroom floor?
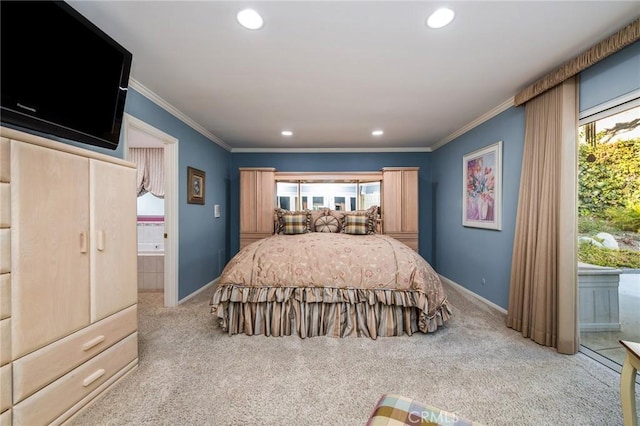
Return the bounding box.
[70,286,636,426]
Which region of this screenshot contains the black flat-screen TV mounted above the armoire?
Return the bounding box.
[0,0,132,149]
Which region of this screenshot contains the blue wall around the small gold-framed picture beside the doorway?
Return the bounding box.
[125,88,231,299]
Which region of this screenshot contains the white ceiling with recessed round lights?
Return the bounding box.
[69,1,640,150]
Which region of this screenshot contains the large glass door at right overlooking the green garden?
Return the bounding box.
[578,99,640,370]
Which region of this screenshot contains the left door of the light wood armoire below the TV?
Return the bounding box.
[11,142,90,359]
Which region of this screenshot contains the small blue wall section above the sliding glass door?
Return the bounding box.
[579,41,640,111]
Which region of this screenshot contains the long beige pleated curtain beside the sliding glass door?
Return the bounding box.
[507,78,579,353]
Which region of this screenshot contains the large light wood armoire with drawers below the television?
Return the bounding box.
[0,128,138,426]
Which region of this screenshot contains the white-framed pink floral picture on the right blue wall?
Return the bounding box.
[462,141,502,231]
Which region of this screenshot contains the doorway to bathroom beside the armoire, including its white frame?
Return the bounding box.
[125,114,178,307]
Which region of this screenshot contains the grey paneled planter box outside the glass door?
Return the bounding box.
[578,263,621,331]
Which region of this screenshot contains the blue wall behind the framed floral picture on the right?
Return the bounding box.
[432,107,525,309]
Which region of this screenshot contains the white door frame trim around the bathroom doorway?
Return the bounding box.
[124,114,179,307]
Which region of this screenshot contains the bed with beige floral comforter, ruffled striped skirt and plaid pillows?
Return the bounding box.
[211,206,451,339]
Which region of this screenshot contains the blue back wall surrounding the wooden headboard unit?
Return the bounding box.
[229,152,433,261]
